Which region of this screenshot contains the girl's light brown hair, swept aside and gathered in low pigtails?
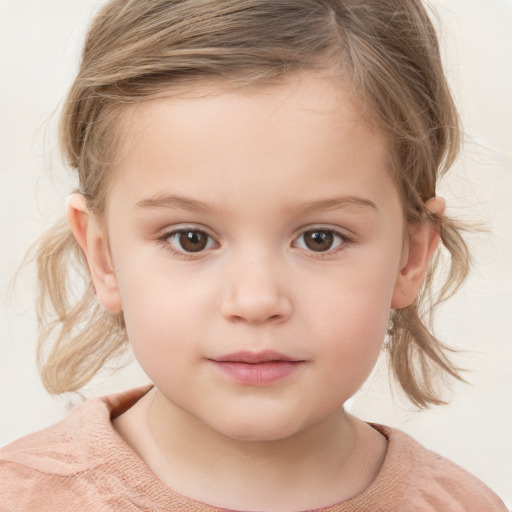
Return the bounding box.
[37,0,469,407]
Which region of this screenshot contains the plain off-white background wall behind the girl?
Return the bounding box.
[0,0,512,507]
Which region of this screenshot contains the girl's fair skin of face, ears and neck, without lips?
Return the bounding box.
[68,74,444,511]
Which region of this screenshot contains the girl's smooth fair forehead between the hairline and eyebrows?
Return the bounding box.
[108,74,402,219]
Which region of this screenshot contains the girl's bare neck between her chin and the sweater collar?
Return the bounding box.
[116,390,385,512]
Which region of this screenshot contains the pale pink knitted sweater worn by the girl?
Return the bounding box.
[0,387,506,512]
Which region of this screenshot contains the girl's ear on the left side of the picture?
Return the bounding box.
[67,193,123,313]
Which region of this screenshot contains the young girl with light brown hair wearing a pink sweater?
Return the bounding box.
[0,0,505,511]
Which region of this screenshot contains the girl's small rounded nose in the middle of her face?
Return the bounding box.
[221,255,292,325]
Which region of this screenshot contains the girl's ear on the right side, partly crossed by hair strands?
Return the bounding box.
[391,197,445,308]
